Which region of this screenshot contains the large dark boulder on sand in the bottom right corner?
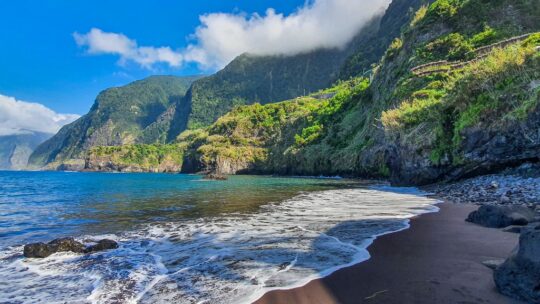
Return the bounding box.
[494,224,540,303]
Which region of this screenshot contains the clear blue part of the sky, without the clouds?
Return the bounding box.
[0,0,304,114]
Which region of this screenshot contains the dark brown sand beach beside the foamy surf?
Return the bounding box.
[256,203,522,304]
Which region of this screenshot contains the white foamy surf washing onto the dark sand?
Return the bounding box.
[0,188,438,303]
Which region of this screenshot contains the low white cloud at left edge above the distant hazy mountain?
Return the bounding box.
[0,95,80,136]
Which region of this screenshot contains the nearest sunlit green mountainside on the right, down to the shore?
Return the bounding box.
[176,0,540,185]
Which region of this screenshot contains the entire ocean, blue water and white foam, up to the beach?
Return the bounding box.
[0,172,438,303]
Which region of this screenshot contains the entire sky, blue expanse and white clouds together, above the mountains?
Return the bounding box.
[0,0,389,135]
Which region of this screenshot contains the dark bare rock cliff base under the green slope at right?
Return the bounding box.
[385,107,540,185]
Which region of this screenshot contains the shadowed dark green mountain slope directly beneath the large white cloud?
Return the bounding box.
[185,0,425,129]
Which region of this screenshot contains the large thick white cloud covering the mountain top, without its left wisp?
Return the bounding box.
[184,0,390,67]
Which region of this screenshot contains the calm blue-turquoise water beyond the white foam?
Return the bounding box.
[0,171,362,246]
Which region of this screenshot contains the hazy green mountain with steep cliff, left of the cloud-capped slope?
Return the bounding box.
[29,76,200,167]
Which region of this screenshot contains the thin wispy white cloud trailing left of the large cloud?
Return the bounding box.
[73,28,183,68]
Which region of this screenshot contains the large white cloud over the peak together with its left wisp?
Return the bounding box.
[74,0,390,69]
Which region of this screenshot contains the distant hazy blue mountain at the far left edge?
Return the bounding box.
[0,131,53,170]
